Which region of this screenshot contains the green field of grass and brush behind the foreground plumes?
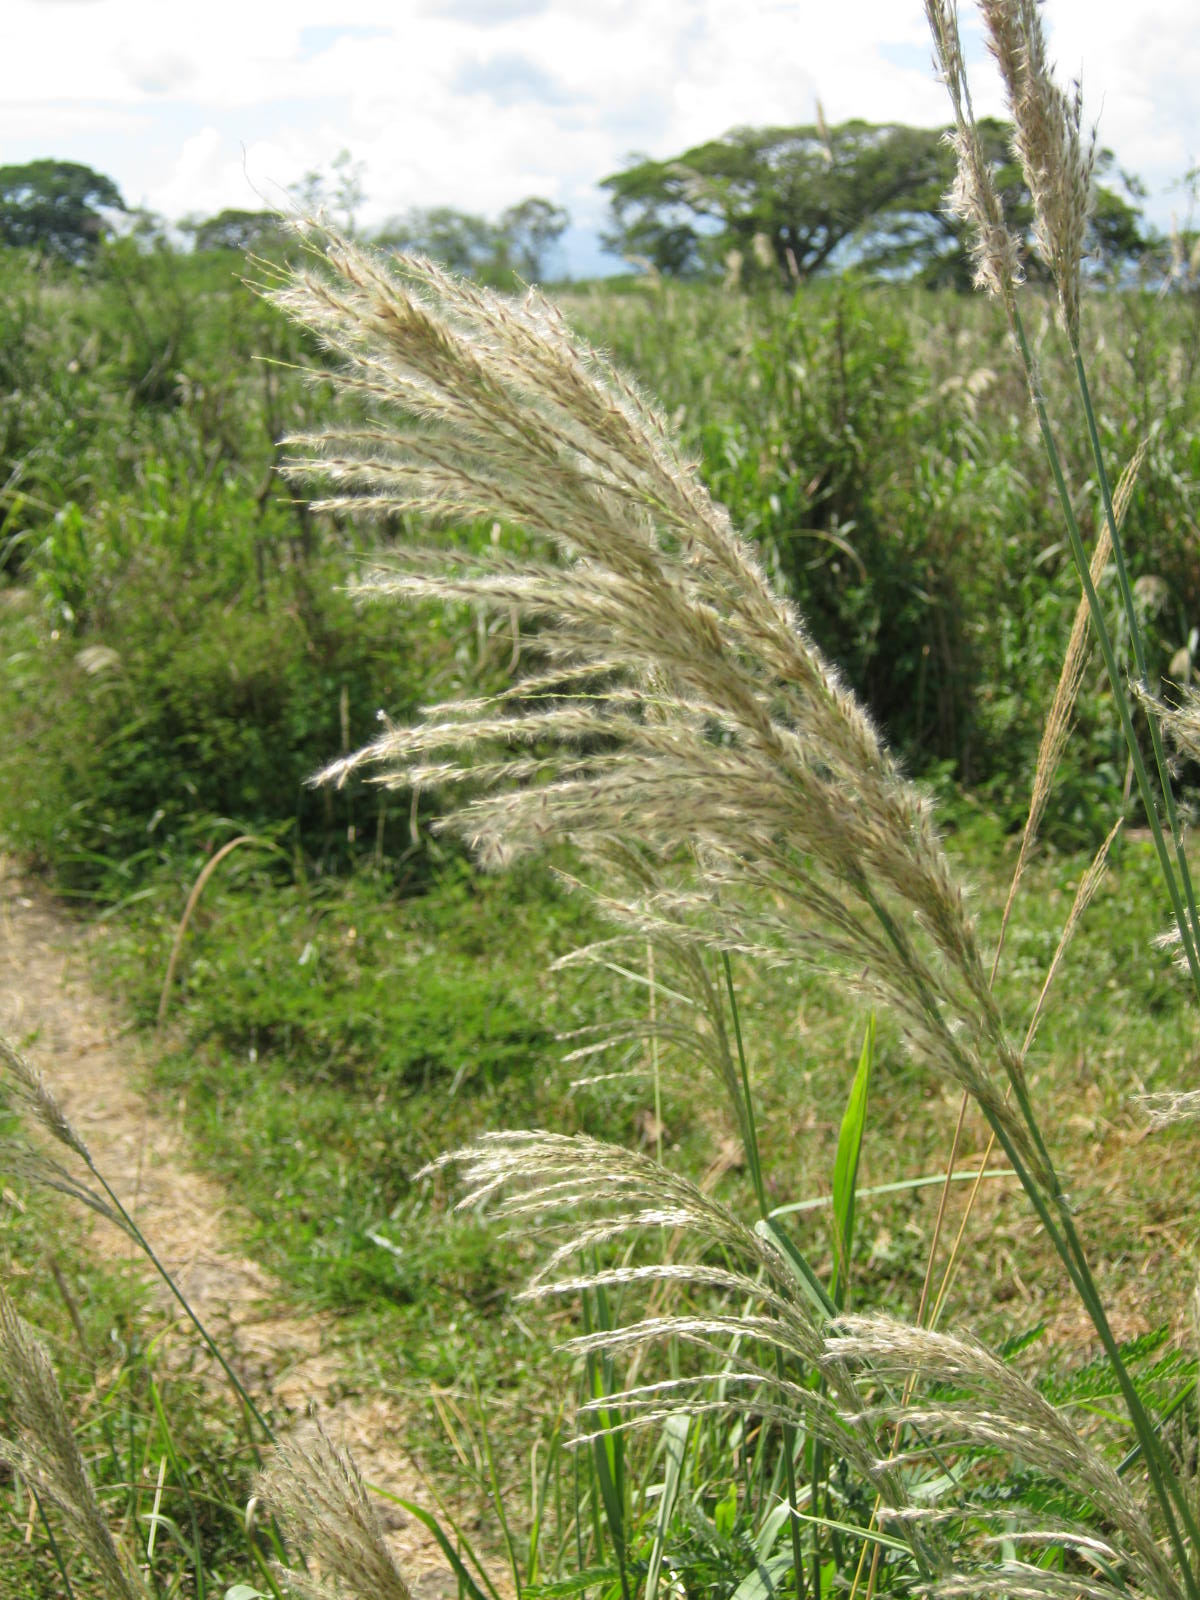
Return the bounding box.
[0,209,1200,1600]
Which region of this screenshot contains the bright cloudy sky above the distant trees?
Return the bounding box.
[0,0,1200,275]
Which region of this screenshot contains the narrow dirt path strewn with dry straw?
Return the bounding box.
[0,856,467,1600]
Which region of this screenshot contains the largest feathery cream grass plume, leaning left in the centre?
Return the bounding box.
[272,237,1053,1189]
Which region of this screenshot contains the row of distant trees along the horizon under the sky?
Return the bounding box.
[0,120,1157,288]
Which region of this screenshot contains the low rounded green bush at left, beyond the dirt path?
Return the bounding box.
[0,474,483,891]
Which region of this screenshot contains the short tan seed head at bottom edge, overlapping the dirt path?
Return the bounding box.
[258,1422,413,1600]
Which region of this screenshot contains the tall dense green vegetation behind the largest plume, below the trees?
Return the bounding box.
[0,242,1200,891]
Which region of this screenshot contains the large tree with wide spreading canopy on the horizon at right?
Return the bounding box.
[602,120,1142,285]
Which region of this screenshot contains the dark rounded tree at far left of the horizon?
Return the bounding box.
[0,160,125,261]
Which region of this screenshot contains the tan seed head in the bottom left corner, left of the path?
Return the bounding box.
[0,1288,149,1600]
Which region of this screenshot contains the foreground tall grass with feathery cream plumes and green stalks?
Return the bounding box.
[8,0,1200,1600]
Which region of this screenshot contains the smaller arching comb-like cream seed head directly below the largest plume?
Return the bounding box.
[427,1133,938,1566]
